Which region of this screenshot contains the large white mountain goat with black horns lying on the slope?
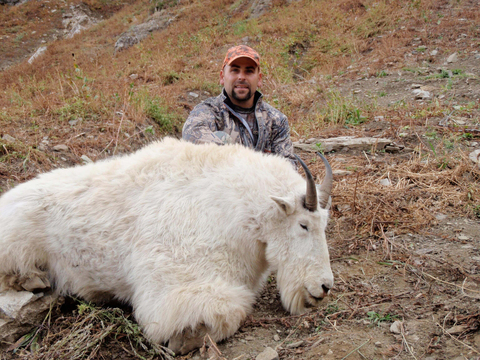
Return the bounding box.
[0,138,333,354]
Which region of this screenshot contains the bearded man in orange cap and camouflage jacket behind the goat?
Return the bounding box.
[182,45,296,168]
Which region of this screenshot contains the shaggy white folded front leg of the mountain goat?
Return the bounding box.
[133,279,255,354]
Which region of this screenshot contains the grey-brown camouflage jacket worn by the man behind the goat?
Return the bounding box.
[182,90,297,168]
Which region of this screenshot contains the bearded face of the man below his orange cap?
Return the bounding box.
[220,57,262,108]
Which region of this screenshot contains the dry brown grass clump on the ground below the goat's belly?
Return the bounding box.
[10,302,174,360]
